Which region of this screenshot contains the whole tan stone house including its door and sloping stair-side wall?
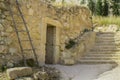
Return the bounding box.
[0,0,95,64]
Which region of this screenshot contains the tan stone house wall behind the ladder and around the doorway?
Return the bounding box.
[0,0,92,64]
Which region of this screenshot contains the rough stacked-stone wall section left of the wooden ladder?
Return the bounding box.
[0,0,19,68]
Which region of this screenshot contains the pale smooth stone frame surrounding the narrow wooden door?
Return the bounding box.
[40,17,62,64]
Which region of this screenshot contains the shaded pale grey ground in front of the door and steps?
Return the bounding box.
[48,64,116,80]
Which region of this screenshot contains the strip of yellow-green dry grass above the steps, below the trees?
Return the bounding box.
[93,16,120,26]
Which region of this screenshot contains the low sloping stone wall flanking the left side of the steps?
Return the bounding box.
[61,32,96,65]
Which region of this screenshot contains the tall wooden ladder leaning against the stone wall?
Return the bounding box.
[8,0,39,66]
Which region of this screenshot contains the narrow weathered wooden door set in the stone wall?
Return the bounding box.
[45,24,56,64]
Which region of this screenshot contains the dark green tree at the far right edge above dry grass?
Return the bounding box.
[112,0,120,16]
